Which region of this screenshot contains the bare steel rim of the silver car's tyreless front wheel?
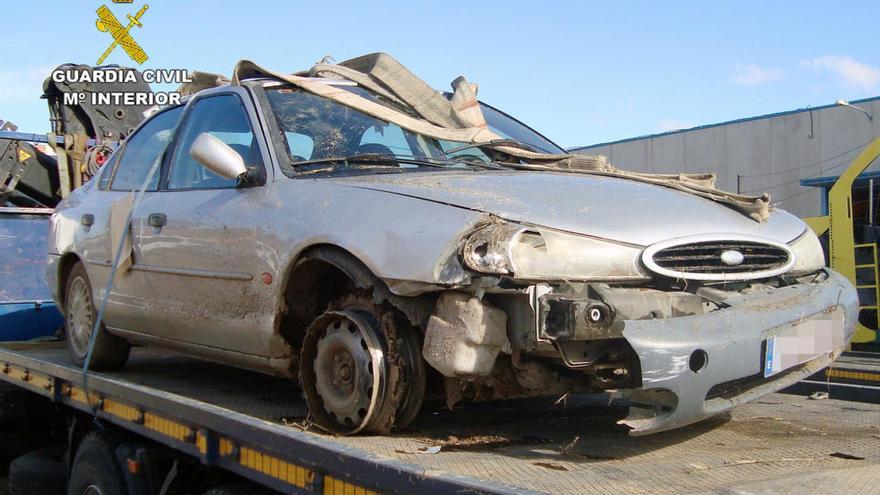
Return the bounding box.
[310,311,387,434]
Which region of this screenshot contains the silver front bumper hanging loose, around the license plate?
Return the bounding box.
[618,271,859,435]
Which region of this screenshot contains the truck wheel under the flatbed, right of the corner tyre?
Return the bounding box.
[67,431,128,495]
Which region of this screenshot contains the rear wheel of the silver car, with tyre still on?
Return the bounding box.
[64,262,131,371]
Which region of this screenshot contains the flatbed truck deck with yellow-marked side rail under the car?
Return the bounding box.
[0,344,880,494]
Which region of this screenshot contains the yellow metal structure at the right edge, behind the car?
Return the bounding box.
[805,138,880,343]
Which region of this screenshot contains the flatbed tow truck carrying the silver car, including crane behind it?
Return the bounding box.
[0,66,880,495]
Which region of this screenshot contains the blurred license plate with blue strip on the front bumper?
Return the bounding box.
[764,310,845,378]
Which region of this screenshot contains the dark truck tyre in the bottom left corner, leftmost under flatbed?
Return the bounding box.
[9,449,67,495]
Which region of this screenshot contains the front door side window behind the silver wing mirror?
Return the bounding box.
[168,95,263,189]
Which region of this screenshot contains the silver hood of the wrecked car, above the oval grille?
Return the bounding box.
[335,172,806,246]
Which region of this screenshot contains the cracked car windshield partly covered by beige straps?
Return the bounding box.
[266,86,563,175]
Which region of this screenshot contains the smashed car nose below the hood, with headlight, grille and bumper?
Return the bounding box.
[425,216,858,435]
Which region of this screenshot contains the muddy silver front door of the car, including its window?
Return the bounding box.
[133,90,277,355]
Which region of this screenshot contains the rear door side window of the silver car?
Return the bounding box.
[111,107,183,191]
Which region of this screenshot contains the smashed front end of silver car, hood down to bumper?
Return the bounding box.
[330,150,858,435]
